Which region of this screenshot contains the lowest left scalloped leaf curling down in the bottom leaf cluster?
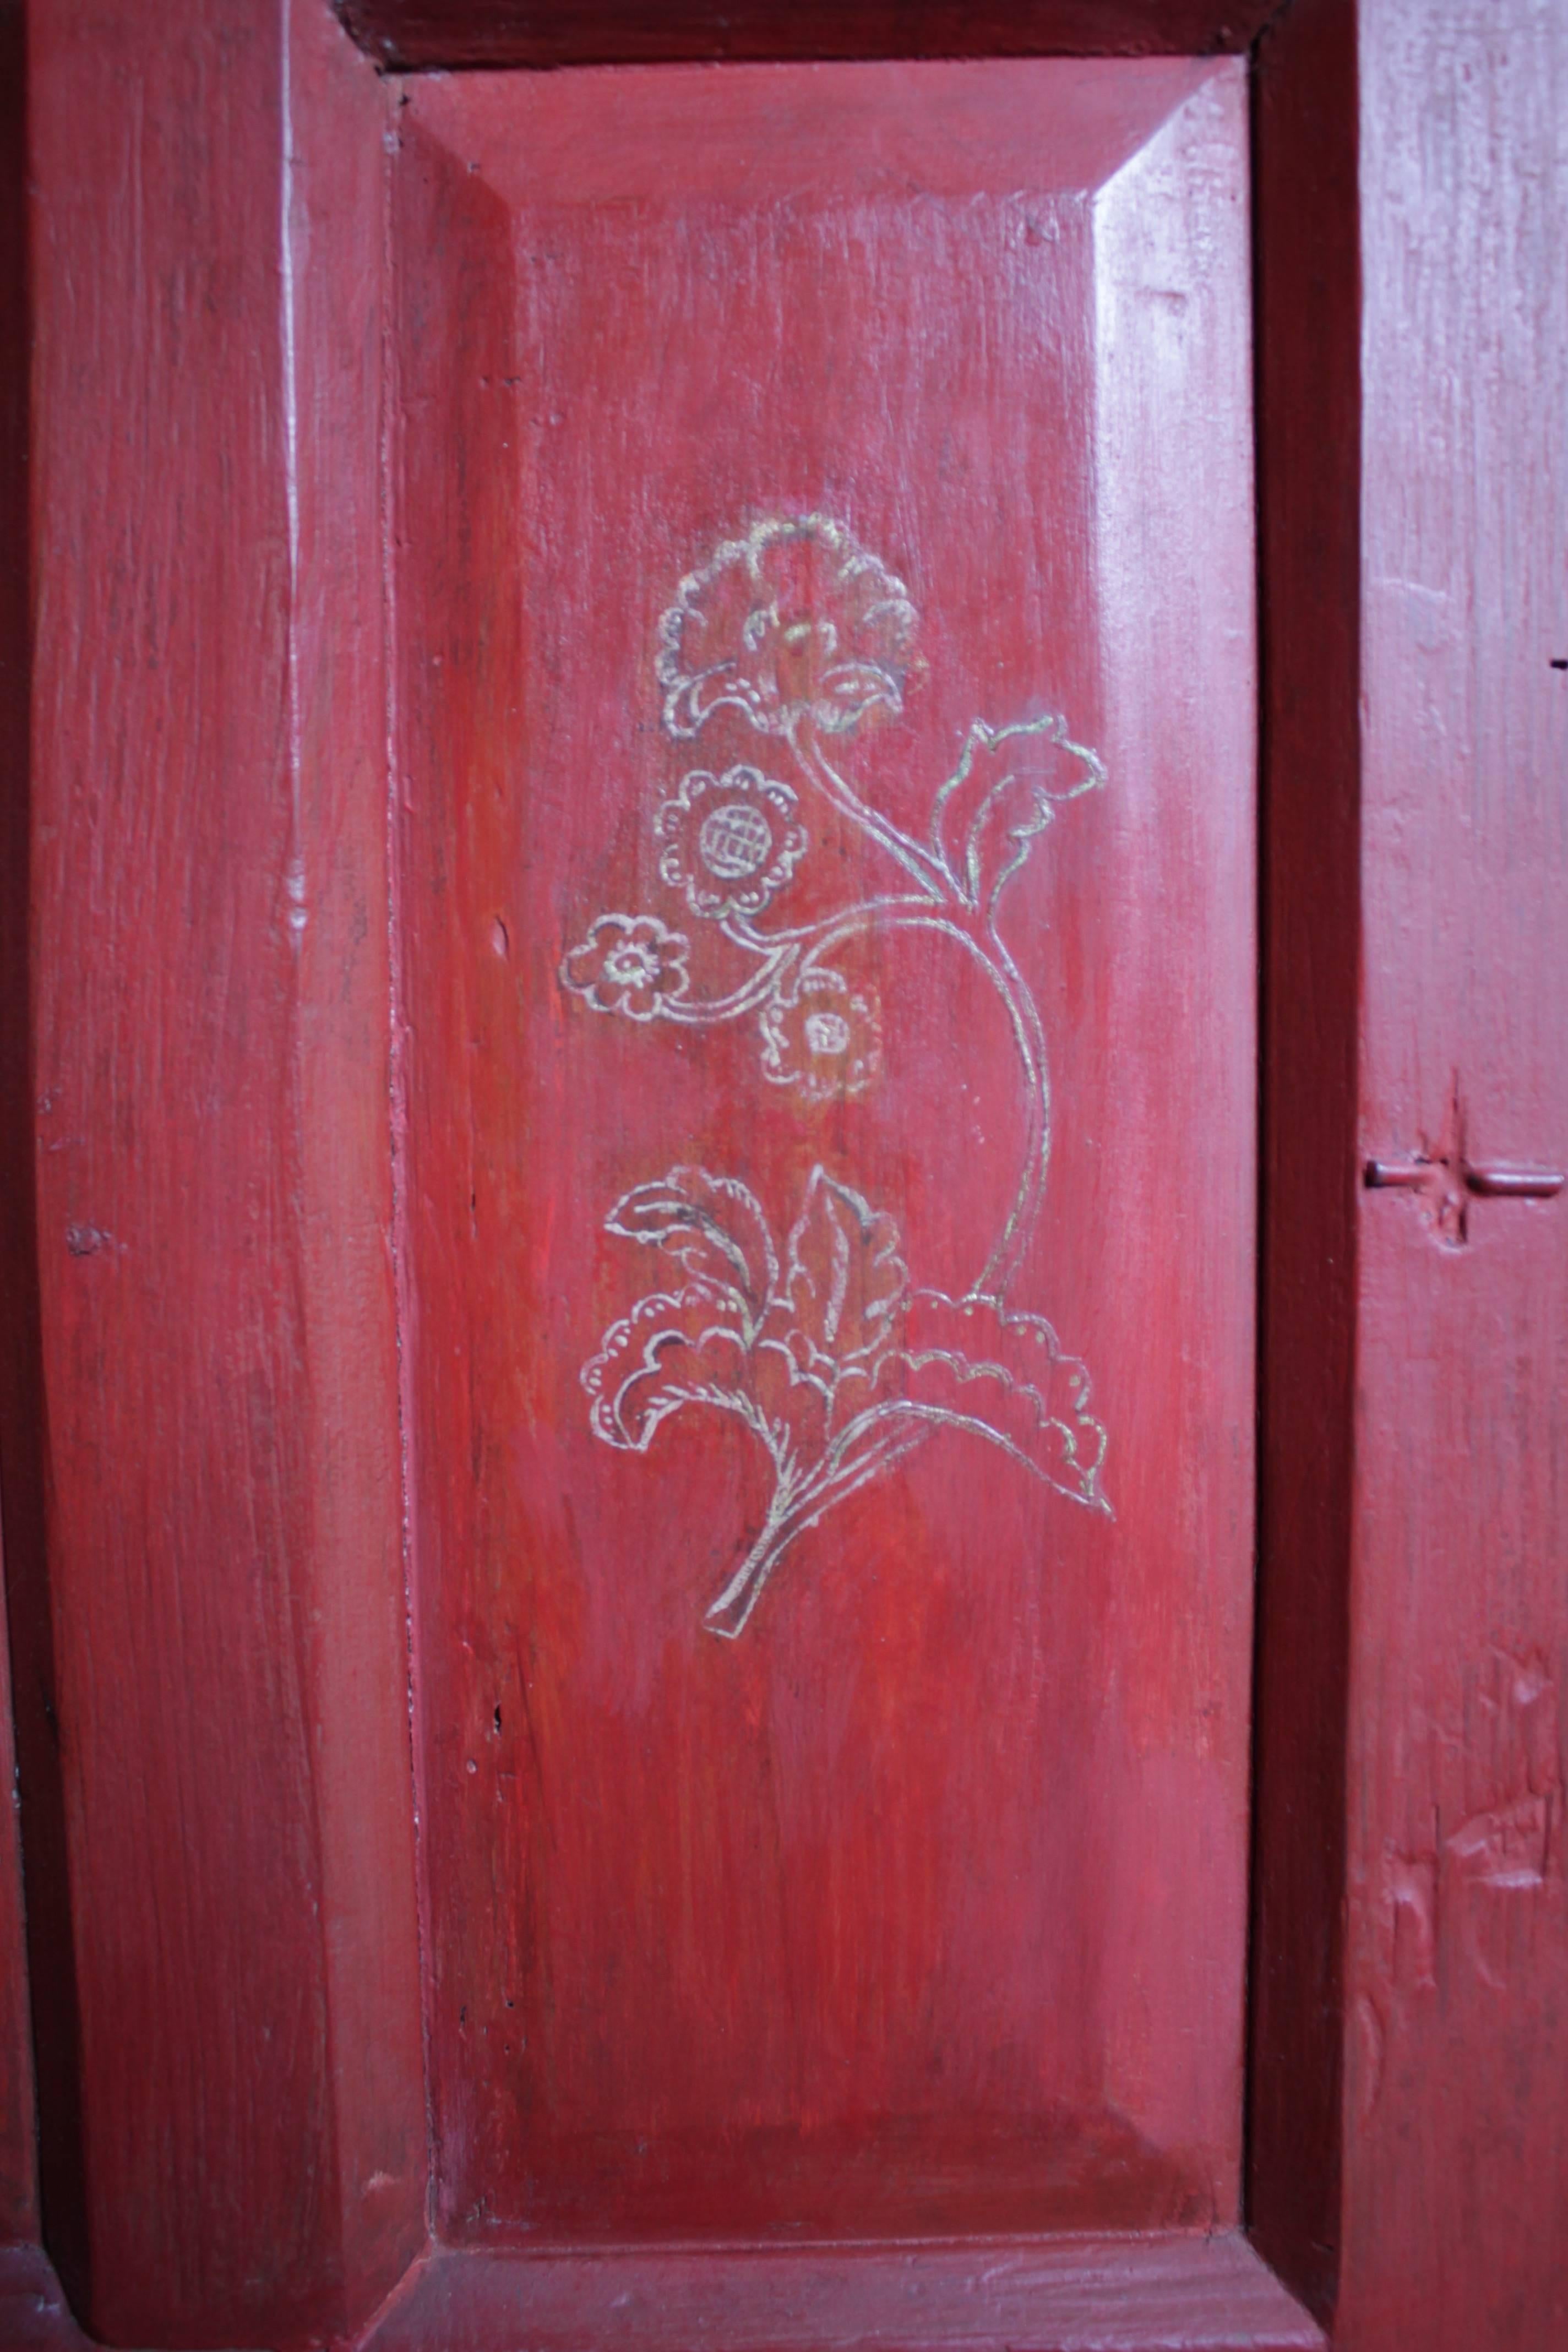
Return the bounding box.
[583,1282,757,1453]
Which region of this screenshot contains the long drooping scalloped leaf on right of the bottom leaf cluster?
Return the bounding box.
[861,1291,1109,1510]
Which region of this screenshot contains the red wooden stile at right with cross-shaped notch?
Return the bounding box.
[1335,0,1568,2352]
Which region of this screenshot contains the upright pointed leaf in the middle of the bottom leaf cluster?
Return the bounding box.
[774,1167,910,1387]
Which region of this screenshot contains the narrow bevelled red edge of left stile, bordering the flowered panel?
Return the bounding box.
[282,0,428,2326]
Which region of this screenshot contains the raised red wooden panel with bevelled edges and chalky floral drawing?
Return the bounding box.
[393,61,1255,2246]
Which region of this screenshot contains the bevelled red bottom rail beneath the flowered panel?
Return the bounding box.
[367,2234,1324,2352]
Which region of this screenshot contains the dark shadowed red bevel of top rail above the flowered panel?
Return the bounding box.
[336,0,1279,70]
